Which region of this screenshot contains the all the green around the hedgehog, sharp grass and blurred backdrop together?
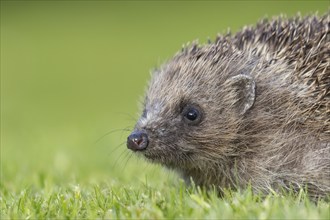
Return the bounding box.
[0,1,330,219]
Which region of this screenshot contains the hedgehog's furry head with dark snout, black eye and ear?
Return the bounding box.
[127,44,255,169]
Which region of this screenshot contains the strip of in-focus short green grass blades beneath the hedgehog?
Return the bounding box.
[1,182,330,219]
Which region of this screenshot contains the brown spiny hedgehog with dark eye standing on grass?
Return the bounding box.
[127,13,330,198]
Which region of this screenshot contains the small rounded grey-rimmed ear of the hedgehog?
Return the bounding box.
[229,74,256,115]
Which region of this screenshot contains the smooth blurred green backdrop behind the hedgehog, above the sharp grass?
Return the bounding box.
[1,1,329,188]
